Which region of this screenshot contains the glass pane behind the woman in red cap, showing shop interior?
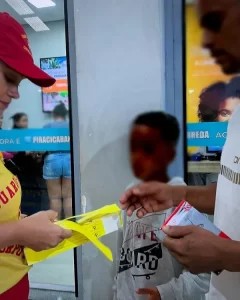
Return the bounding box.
[0,0,75,299]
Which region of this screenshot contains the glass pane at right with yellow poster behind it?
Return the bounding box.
[185,1,227,192]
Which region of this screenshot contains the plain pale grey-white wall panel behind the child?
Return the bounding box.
[73,0,164,300]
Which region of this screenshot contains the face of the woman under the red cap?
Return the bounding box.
[0,61,23,114]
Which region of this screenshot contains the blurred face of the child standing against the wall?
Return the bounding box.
[130,125,175,181]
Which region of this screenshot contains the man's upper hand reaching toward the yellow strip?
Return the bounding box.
[120,181,185,218]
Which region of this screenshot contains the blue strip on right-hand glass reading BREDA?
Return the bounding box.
[187,122,228,147]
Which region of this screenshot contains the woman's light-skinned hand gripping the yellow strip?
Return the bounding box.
[16,211,72,251]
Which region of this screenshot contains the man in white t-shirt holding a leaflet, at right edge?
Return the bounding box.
[120,0,240,300]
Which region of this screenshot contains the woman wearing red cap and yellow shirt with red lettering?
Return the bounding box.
[0,13,71,300]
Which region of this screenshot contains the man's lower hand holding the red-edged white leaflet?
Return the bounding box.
[162,225,227,274]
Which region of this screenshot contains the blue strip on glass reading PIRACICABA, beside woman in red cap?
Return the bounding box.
[0,128,70,152]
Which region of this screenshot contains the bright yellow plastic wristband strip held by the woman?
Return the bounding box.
[24,204,122,266]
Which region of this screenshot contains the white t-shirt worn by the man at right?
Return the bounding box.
[207,105,240,300]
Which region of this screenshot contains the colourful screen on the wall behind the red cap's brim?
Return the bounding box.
[40,56,69,112]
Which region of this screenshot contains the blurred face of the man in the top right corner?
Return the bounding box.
[196,0,240,74]
